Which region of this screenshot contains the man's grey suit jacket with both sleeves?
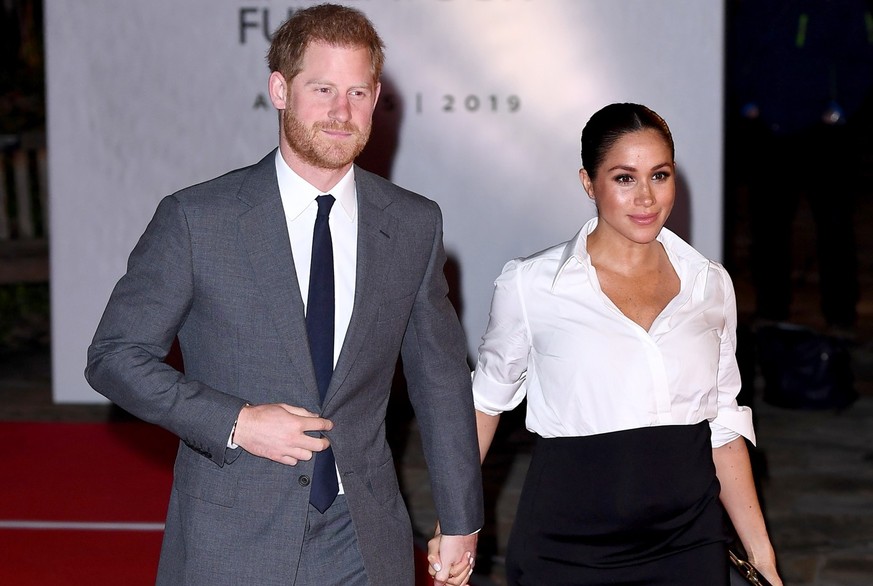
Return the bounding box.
[86,151,483,586]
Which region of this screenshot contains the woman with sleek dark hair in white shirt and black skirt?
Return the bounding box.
[428,104,781,586]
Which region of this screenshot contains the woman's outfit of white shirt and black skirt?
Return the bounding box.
[473,218,755,586]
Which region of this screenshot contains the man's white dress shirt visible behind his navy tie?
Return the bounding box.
[276,151,358,494]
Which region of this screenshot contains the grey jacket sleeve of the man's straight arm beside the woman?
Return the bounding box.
[402,202,484,535]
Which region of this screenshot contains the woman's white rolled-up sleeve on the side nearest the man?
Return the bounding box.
[473,260,530,415]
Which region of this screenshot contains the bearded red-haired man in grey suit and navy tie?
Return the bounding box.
[86,5,483,586]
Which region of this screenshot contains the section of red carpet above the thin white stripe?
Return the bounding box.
[0,423,178,523]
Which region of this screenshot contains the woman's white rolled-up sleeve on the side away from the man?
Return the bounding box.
[710,269,756,448]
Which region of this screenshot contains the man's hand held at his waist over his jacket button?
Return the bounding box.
[233,403,333,466]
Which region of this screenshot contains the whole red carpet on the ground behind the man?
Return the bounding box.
[0,422,432,586]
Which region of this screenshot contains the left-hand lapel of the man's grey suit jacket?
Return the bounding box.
[238,150,318,401]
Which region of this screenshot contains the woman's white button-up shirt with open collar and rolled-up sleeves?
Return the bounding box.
[473,218,755,447]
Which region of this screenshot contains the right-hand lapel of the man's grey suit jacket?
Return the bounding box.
[324,168,397,404]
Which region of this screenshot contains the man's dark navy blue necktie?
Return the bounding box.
[306,195,339,513]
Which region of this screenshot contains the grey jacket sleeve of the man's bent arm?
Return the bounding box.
[85,196,245,465]
